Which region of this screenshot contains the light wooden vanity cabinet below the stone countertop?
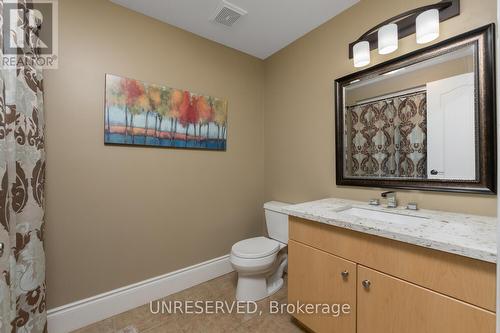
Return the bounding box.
[288,217,496,333]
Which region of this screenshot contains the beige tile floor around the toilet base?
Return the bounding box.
[70,273,304,333]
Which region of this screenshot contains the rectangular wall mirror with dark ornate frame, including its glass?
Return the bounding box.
[335,24,496,194]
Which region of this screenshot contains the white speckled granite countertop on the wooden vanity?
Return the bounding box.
[282,198,497,263]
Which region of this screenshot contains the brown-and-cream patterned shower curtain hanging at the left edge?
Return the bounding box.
[0,0,47,333]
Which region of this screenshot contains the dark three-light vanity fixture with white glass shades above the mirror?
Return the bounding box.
[349,0,460,67]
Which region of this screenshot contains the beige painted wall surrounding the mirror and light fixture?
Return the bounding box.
[264,0,496,215]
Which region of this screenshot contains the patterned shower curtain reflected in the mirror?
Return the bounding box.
[346,91,427,178]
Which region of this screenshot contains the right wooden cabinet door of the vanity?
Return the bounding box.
[357,266,495,333]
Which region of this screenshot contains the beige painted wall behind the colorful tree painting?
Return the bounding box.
[44,0,264,308]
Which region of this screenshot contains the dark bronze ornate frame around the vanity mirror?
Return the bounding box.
[335,24,497,194]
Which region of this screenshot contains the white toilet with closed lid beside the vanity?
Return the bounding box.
[230,201,289,302]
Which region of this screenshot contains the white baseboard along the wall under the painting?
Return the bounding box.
[47,255,233,333]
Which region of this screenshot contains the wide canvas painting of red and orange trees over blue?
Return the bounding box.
[104,74,227,150]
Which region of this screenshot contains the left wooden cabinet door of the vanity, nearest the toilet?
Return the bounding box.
[288,240,356,333]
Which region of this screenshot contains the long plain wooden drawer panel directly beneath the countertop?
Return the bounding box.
[289,217,496,311]
